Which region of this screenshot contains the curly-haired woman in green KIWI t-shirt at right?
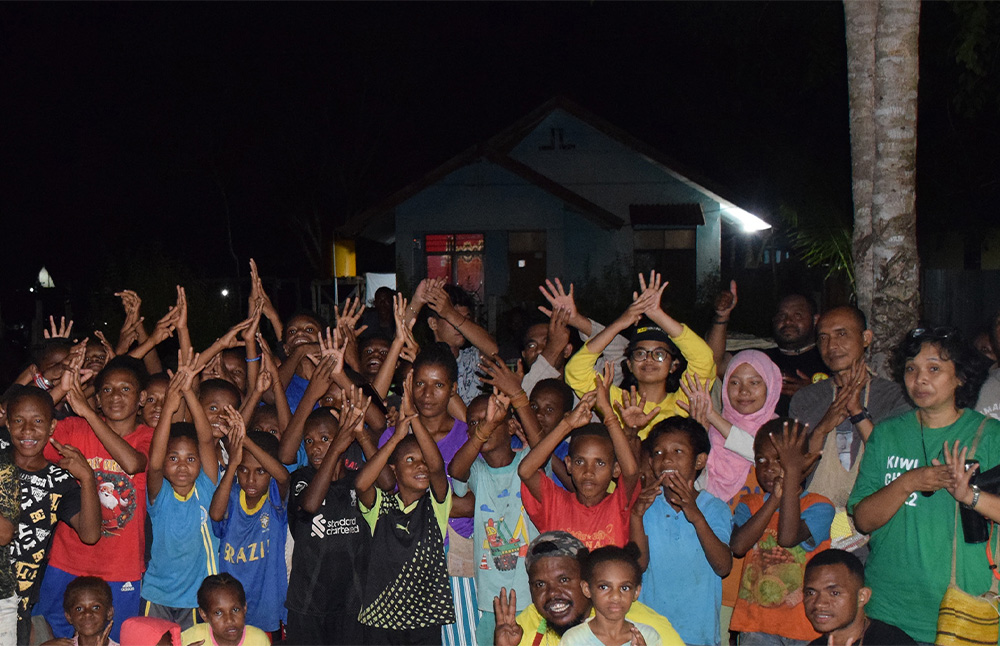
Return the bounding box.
[847,328,1000,642]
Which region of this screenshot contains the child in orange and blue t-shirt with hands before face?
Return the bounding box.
[729,417,834,646]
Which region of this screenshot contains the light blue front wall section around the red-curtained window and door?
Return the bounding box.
[395,160,632,296]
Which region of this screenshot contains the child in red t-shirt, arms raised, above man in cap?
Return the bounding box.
[517,364,639,549]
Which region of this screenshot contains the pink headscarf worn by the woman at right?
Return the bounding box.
[705,350,781,501]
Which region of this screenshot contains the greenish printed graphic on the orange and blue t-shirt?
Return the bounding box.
[740,528,808,608]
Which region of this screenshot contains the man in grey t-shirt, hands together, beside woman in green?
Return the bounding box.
[789,306,911,554]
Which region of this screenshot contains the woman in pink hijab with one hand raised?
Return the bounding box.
[682,350,781,501]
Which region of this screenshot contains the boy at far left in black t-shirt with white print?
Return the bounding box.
[6,386,101,644]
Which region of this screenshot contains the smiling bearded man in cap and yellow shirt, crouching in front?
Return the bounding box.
[493,531,684,646]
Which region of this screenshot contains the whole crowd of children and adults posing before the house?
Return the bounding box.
[0,262,1000,646]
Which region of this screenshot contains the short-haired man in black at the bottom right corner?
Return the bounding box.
[802,549,916,646]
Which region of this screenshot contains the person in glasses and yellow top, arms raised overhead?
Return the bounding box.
[566,272,715,439]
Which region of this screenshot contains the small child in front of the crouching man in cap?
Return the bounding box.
[559,543,672,646]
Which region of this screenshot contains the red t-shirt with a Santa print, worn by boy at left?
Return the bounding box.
[45,417,153,581]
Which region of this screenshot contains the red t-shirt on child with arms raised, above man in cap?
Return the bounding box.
[521,473,642,550]
